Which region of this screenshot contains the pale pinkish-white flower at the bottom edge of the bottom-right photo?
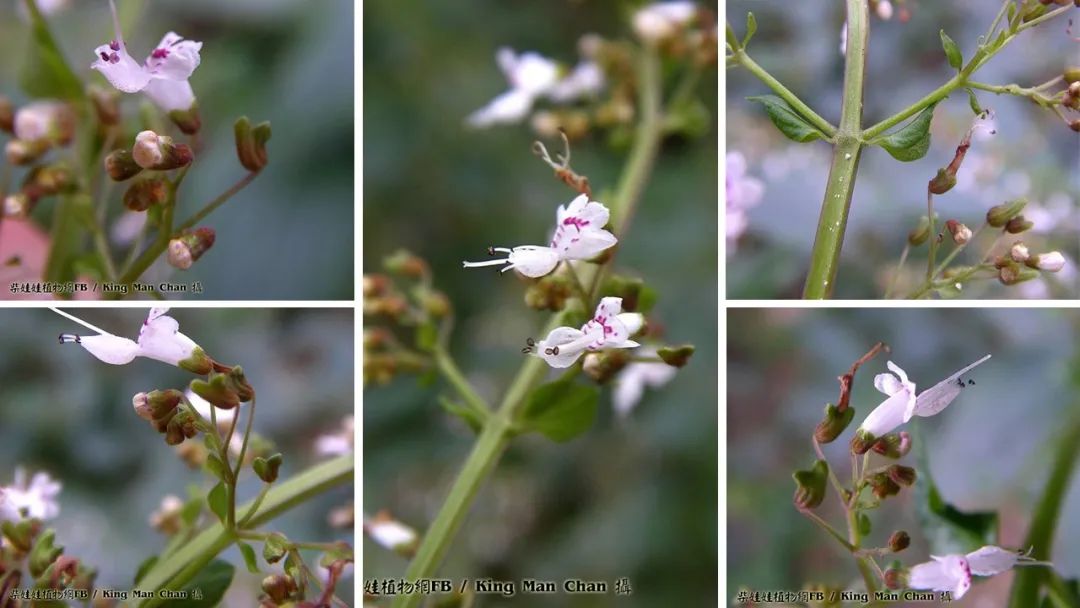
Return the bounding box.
[907,545,1050,599]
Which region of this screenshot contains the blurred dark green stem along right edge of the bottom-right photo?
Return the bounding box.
[1009,412,1080,608]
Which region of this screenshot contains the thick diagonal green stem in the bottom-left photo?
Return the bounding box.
[132,455,353,608]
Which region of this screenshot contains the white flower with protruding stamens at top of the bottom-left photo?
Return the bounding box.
[52,308,213,375]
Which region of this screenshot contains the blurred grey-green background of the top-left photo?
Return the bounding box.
[0,0,354,300]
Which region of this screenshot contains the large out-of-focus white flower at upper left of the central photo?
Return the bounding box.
[465,48,558,129]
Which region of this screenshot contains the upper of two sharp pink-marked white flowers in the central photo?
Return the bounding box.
[462,194,618,279]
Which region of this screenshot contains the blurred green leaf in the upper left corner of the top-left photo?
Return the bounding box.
[18,0,83,99]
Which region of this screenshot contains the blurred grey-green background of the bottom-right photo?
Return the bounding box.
[727,309,1080,607]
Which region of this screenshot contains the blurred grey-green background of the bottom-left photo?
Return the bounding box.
[0,309,353,608]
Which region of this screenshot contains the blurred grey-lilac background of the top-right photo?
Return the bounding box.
[726,0,1080,298]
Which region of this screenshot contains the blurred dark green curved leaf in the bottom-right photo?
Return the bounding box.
[915,437,998,555]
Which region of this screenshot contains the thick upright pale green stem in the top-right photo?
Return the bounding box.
[802,0,869,299]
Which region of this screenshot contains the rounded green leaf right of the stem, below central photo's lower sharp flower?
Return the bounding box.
[522,378,599,443]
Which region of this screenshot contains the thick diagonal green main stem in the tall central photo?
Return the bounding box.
[393,44,662,608]
